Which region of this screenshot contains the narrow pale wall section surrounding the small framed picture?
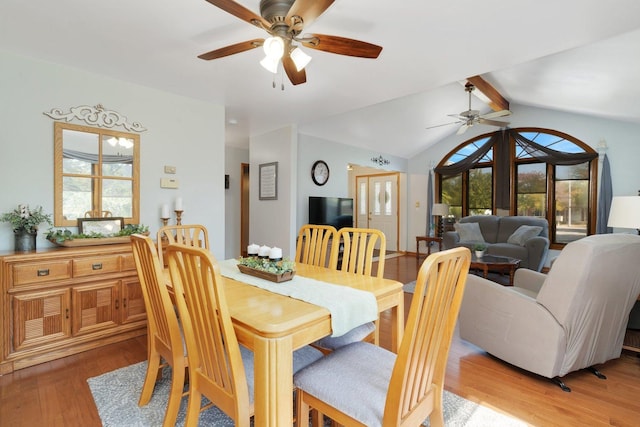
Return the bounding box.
[249,126,298,258]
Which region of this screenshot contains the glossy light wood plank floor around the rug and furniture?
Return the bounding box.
[0,256,640,427]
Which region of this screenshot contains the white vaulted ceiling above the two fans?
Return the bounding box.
[0,0,640,158]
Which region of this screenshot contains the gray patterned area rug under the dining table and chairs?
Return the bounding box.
[87,362,527,427]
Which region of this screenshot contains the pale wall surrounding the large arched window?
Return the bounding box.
[408,104,640,249]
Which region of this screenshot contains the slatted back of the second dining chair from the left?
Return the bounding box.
[167,243,253,426]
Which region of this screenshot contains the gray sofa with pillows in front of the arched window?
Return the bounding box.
[443,215,549,271]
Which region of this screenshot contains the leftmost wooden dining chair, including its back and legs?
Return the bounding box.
[131,234,188,427]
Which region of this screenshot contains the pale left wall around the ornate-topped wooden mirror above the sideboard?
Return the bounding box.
[0,52,225,258]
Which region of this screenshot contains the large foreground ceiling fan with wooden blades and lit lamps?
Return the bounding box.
[198,0,382,85]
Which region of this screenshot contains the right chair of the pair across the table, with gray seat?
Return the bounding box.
[314,227,387,354]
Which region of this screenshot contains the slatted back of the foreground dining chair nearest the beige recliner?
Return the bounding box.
[383,247,471,426]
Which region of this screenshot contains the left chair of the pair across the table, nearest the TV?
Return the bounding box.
[295,224,338,267]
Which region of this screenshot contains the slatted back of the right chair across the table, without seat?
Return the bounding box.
[331,227,387,277]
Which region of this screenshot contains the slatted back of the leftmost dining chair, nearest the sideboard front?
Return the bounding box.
[131,234,184,360]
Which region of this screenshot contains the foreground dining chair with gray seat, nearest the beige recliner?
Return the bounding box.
[294,248,471,427]
